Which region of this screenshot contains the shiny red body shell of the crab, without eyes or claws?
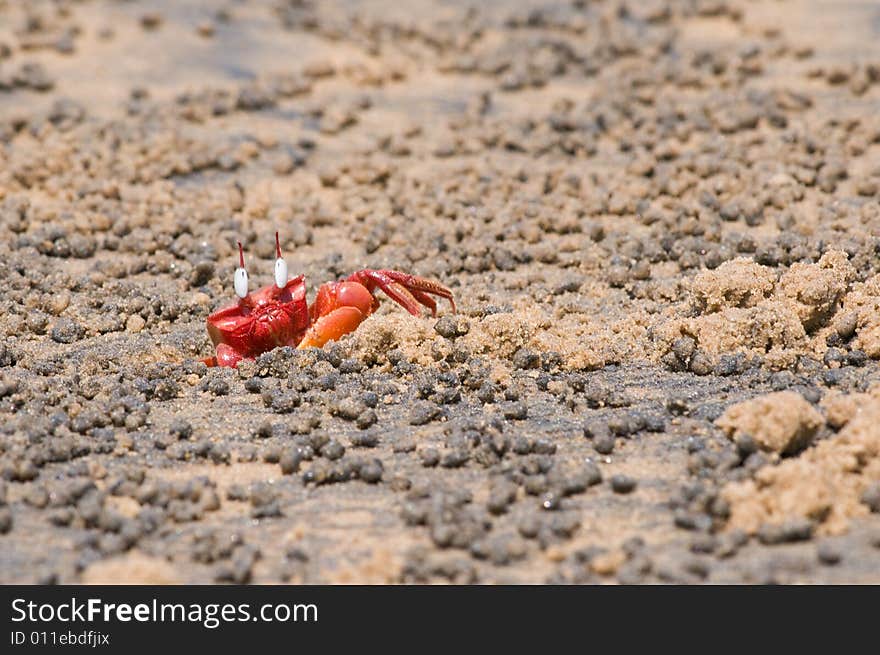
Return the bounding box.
[207,275,309,357]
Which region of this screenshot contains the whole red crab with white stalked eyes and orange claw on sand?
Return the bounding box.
[202,232,455,367]
